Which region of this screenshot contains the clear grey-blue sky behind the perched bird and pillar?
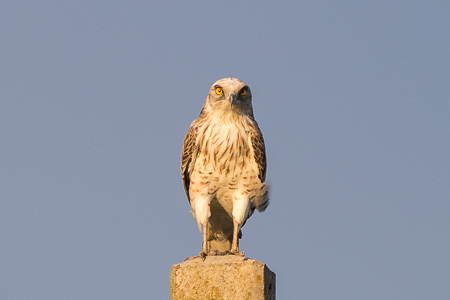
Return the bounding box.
[0,0,450,300]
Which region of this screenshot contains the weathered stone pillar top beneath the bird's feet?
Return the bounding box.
[170,255,275,300]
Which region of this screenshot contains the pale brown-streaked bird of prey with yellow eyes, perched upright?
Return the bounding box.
[181,78,269,257]
